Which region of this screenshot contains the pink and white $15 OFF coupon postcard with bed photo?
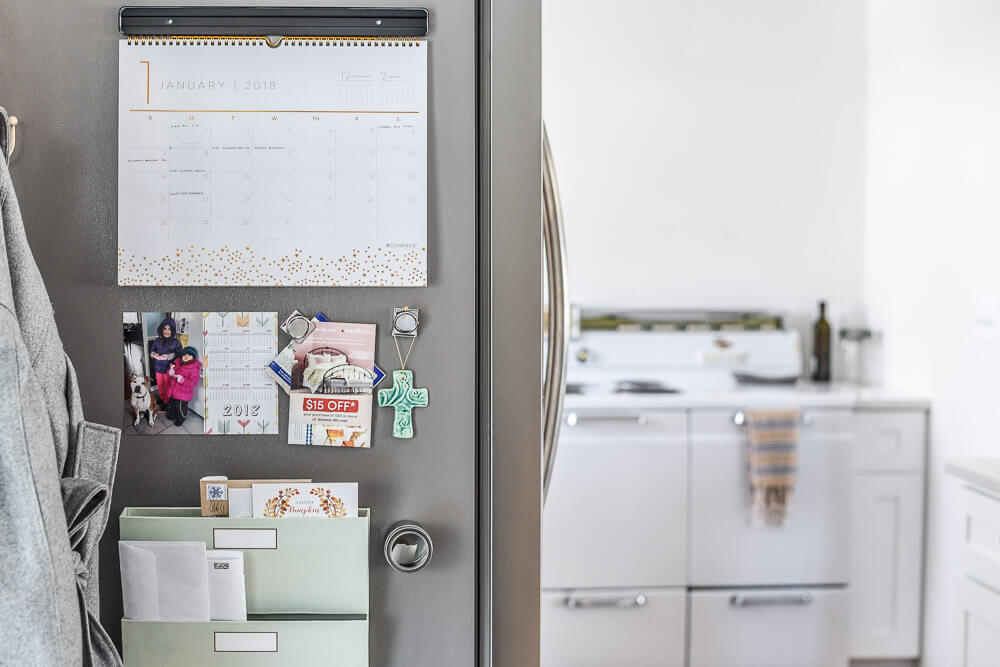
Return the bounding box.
[288,322,375,447]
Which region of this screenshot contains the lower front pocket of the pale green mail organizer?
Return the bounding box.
[122,620,368,667]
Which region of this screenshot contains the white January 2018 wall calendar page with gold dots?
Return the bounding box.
[118,38,427,286]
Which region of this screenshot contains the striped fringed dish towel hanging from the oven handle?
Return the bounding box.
[745,409,799,526]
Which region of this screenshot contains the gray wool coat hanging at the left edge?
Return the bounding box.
[0,109,121,667]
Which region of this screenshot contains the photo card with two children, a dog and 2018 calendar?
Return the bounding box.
[122,311,278,435]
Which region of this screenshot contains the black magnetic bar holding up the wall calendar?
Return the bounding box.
[118,6,428,37]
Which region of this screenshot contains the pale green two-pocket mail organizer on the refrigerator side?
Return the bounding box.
[119,507,369,667]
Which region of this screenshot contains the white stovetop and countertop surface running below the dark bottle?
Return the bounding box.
[565,382,930,410]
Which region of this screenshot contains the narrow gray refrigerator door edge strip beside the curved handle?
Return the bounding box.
[480,0,542,667]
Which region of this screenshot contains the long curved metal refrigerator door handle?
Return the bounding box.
[542,124,570,502]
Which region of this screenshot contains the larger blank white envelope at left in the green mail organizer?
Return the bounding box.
[118,541,209,621]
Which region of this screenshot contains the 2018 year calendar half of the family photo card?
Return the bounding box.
[203,313,278,435]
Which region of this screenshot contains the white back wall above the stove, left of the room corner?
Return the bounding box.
[542,0,865,334]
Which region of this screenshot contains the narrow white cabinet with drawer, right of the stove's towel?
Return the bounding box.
[850,410,926,659]
